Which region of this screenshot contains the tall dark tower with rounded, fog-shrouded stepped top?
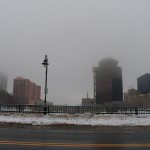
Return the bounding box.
[93,58,123,104]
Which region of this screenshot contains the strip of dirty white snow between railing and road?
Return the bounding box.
[0,113,150,126]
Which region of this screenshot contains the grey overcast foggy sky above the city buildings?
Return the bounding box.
[0,0,150,105]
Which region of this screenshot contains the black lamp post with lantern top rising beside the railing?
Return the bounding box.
[42,55,49,115]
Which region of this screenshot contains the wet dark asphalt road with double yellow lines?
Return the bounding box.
[0,128,150,150]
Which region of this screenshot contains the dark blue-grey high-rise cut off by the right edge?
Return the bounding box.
[137,73,150,94]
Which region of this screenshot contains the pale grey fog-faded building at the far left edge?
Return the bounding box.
[0,73,8,91]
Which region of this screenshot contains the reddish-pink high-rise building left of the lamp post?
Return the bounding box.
[13,77,41,104]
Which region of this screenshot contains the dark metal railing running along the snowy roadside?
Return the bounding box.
[0,105,150,115]
